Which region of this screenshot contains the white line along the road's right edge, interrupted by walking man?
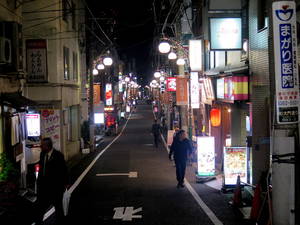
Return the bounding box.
[161,135,223,225]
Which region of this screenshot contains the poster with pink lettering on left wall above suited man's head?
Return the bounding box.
[41,109,61,151]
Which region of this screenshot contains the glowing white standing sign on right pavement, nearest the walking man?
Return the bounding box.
[197,137,215,176]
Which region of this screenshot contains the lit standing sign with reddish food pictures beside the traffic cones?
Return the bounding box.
[223,147,247,186]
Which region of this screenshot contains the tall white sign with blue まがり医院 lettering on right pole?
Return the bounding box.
[272,1,299,124]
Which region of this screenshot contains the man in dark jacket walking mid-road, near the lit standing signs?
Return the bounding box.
[169,130,193,188]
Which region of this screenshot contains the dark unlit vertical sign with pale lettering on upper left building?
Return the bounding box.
[26,39,47,82]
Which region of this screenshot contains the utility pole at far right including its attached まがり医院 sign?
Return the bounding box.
[268,0,300,225]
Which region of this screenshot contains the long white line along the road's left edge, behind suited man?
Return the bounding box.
[33,114,131,224]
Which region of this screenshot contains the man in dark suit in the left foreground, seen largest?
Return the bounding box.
[35,138,68,225]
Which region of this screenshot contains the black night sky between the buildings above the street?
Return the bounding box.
[87,0,155,84]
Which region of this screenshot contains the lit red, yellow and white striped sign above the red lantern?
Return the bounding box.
[217,76,249,101]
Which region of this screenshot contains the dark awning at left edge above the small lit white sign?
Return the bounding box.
[0,92,37,109]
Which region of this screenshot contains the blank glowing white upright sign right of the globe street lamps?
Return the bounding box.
[189,40,202,71]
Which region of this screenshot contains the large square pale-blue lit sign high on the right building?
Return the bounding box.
[210,18,242,51]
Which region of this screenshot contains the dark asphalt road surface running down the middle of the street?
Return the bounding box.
[68,105,243,225]
